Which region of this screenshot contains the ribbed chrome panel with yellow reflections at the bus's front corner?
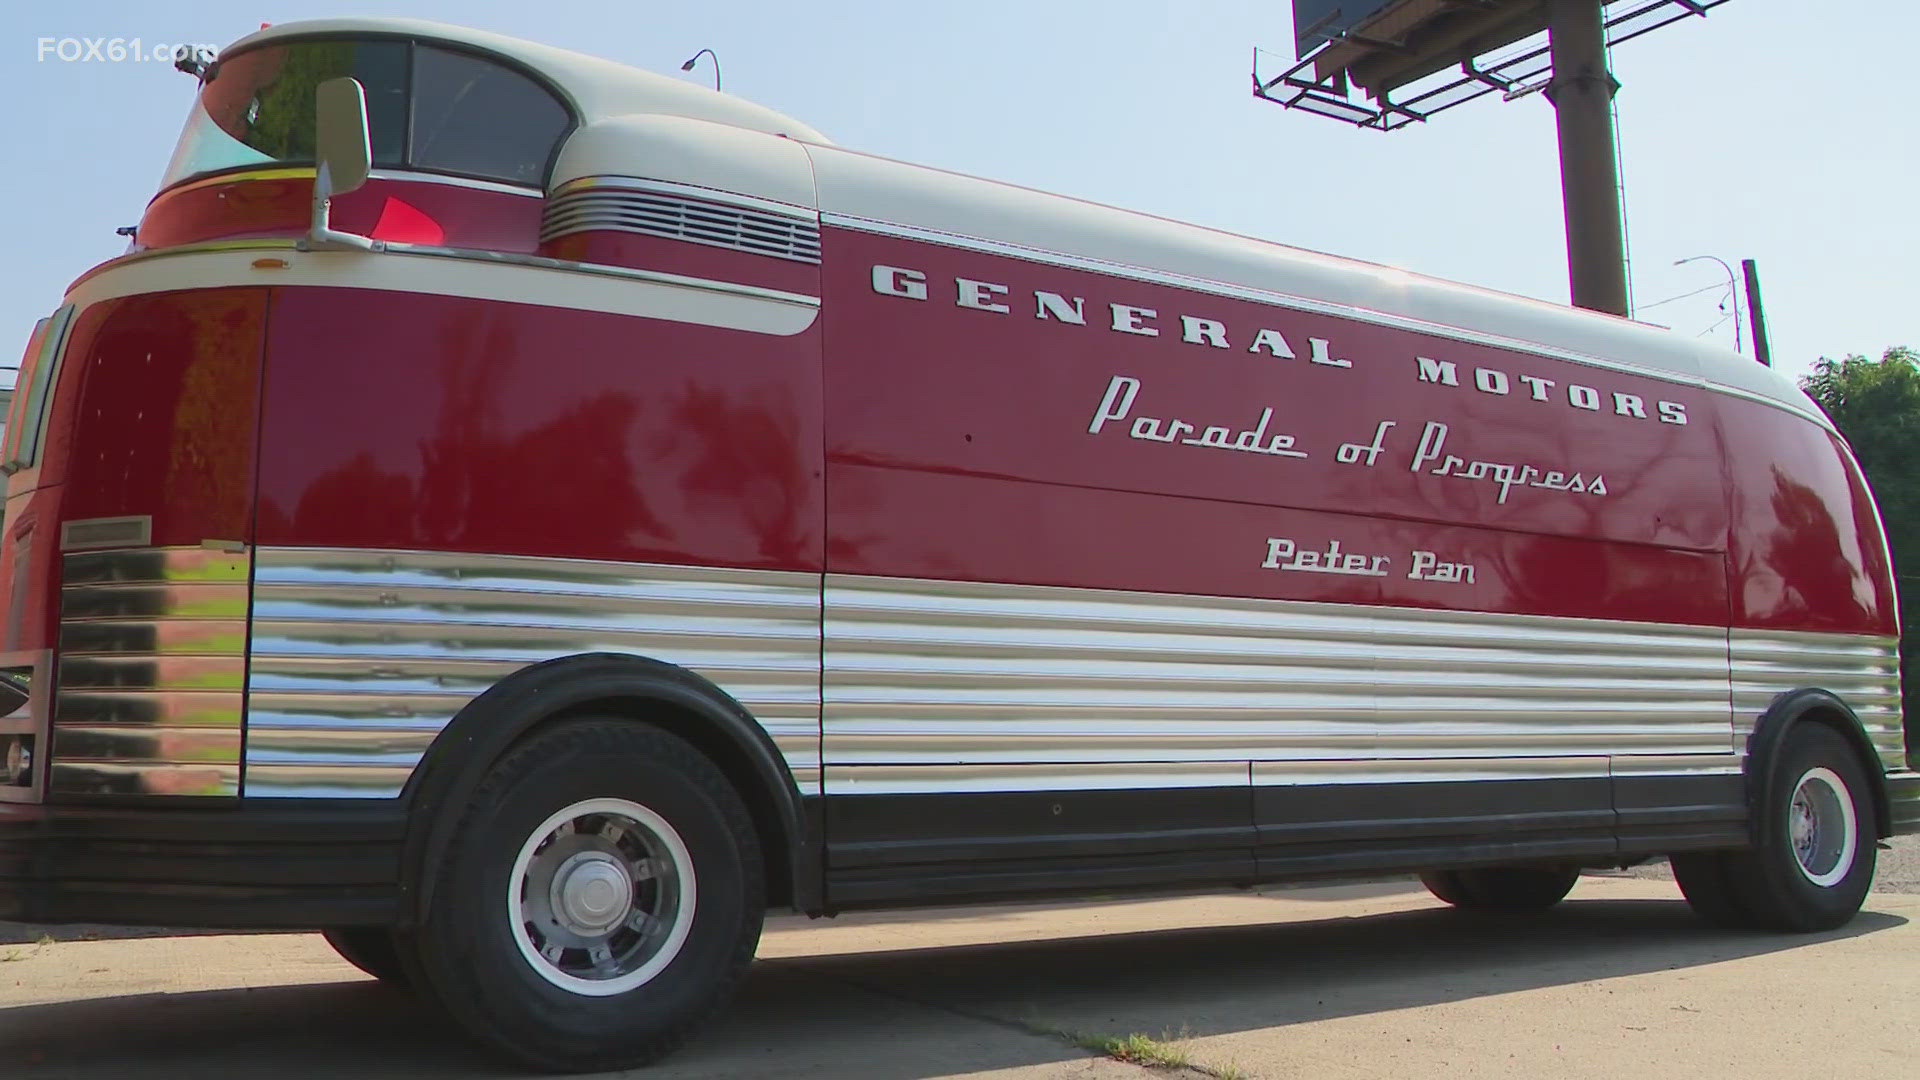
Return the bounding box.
[48,548,248,796]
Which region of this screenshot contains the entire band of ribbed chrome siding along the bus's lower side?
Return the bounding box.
[220,550,1901,798]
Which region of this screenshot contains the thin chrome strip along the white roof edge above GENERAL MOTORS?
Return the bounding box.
[820,211,1836,430]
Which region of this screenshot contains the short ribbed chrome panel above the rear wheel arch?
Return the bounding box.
[1732,630,1907,769]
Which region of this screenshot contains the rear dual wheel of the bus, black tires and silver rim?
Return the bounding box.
[1674,723,1878,932]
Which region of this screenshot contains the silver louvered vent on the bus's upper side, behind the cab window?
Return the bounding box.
[540,181,820,263]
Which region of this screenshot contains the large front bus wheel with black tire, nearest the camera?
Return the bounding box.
[411,721,766,1072]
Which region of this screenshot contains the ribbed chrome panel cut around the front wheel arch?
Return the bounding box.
[246,548,820,798]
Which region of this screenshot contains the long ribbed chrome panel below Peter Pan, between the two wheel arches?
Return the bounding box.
[822,575,1732,764]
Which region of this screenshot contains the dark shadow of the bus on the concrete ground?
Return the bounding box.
[0,899,1907,1080]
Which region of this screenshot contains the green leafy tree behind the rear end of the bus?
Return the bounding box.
[1801,346,1920,757]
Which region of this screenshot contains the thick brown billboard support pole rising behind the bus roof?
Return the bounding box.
[1546,0,1626,315]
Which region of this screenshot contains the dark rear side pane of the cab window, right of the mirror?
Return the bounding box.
[409,46,568,184]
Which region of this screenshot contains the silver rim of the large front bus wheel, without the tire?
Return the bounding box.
[507,799,697,997]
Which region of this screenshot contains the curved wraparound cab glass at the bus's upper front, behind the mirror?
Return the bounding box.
[161,40,572,188]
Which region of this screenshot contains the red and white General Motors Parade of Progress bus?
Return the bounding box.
[0,19,1920,1068]
